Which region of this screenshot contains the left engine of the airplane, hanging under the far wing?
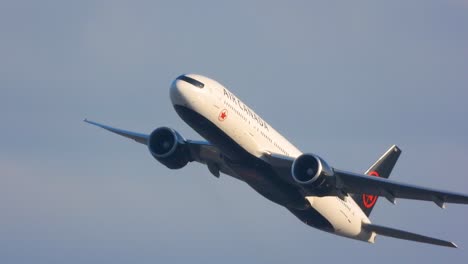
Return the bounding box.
[148,127,190,170]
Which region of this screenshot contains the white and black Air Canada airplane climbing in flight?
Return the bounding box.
[84,74,468,248]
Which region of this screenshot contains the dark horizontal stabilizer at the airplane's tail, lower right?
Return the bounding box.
[362,224,457,248]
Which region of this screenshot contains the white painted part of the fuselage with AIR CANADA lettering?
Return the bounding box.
[170,74,375,243]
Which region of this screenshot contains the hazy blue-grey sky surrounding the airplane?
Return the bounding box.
[0,0,468,264]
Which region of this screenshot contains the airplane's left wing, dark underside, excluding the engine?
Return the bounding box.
[84,119,240,179]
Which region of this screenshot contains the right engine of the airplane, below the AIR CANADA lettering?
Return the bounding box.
[291,154,334,189]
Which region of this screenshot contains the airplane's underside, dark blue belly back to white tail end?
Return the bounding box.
[174,105,369,240]
